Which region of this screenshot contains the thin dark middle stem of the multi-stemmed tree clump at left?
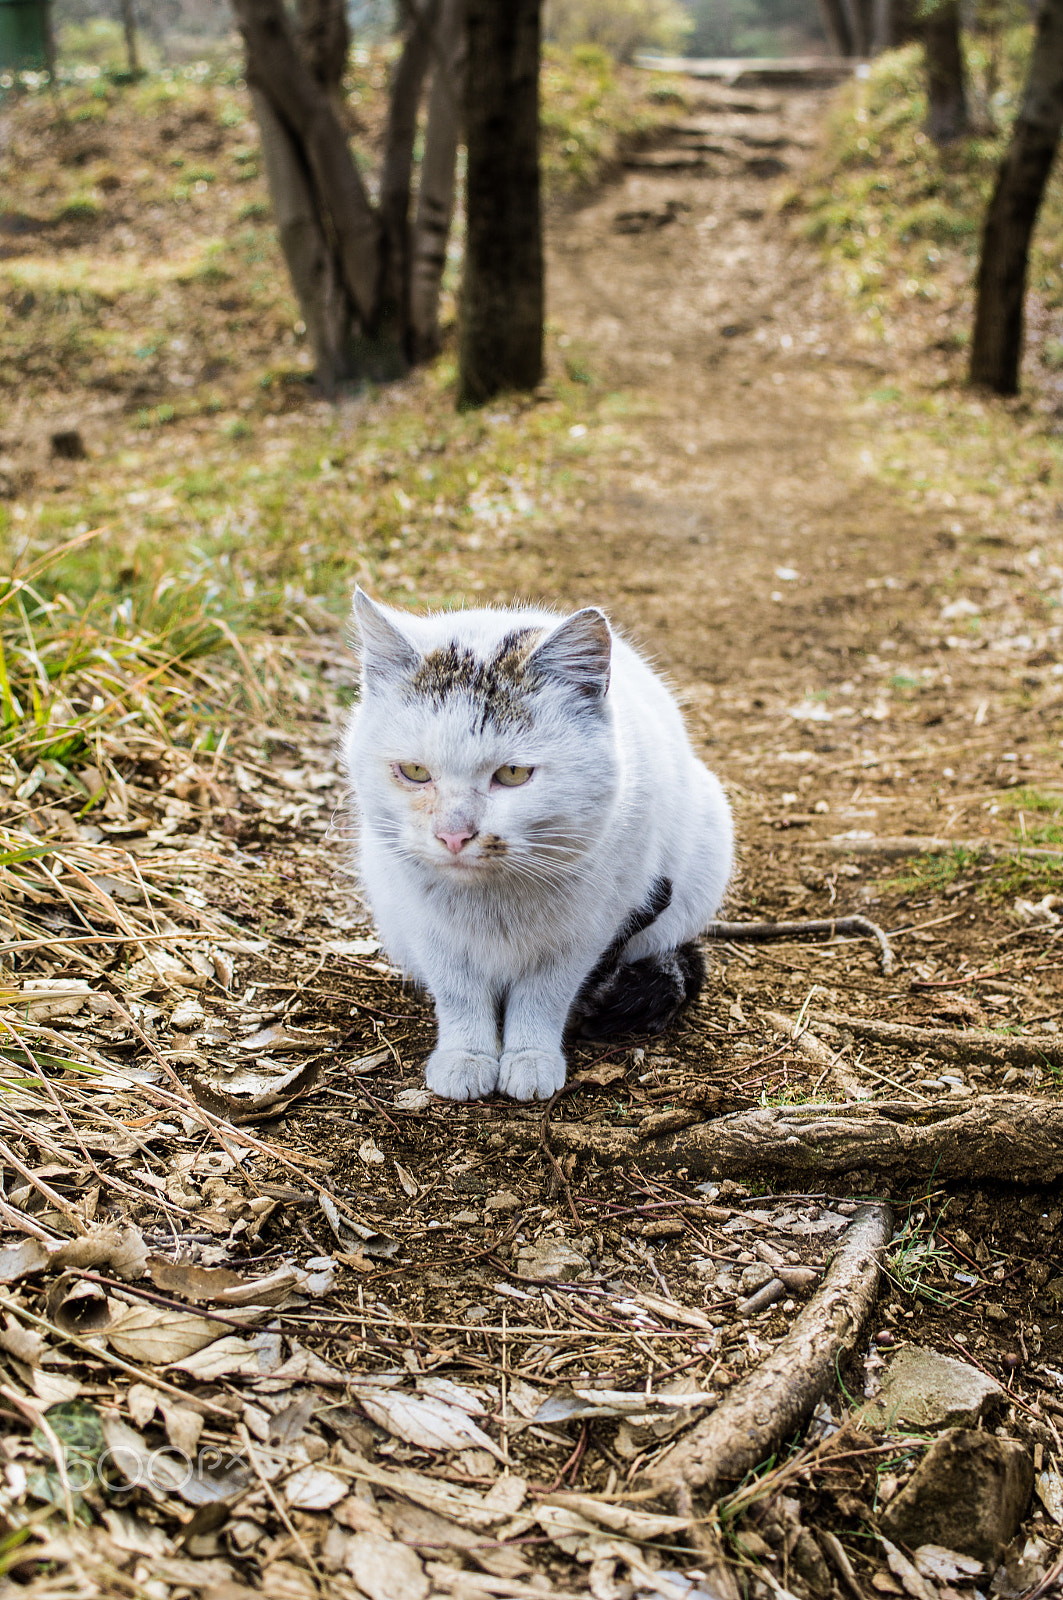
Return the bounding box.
[376,0,440,363]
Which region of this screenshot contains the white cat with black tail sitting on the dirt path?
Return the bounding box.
[344,590,732,1099]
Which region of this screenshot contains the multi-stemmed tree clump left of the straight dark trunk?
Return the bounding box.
[232,0,456,394]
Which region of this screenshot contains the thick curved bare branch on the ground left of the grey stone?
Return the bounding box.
[648,1205,893,1504]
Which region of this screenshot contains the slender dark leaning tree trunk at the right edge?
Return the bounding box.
[970,0,1063,395]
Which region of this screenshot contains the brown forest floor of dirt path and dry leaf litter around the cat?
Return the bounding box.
[0,68,1063,1600]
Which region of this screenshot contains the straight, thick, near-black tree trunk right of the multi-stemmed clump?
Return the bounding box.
[458,0,543,405]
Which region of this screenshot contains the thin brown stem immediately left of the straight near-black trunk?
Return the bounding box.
[410,0,464,362]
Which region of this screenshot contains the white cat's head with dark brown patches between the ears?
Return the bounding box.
[344,590,616,885]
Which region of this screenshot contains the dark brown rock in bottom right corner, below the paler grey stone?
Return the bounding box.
[880,1427,1034,1562]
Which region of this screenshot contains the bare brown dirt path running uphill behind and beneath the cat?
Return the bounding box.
[2,68,1063,1592]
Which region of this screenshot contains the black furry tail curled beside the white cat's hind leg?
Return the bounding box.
[568,878,704,1038]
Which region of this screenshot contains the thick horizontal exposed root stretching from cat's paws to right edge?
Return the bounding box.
[528,1094,1063,1189]
